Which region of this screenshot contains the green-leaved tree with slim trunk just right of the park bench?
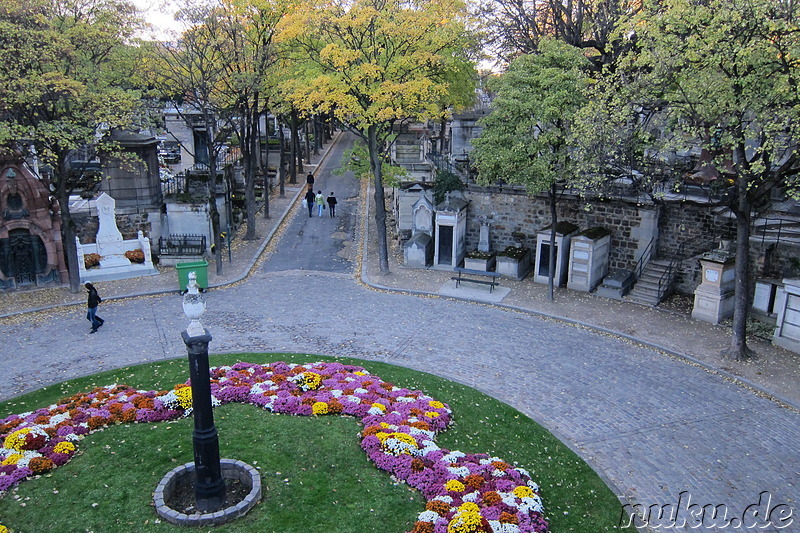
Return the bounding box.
[472,39,589,301]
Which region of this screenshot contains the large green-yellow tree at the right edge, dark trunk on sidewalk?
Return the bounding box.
[592,0,800,359]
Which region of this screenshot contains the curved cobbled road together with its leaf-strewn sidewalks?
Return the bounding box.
[0,132,800,531]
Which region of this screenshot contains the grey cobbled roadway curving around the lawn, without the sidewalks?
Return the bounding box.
[0,131,800,531]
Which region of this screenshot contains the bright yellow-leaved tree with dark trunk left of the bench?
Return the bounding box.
[283,0,474,274]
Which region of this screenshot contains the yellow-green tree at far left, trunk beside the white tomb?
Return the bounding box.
[0,0,140,293]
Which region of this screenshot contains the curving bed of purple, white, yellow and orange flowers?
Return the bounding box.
[0,362,547,533]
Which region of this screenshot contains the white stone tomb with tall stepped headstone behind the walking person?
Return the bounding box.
[75,193,158,283]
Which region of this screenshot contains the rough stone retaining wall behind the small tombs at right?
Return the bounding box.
[456,185,800,294]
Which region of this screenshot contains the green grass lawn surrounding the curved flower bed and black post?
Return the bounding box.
[0,354,632,533]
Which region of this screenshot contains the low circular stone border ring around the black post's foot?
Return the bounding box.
[153,459,261,527]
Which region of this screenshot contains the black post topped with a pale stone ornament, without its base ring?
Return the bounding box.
[181,272,225,513]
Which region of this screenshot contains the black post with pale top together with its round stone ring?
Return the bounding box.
[153,272,261,527]
